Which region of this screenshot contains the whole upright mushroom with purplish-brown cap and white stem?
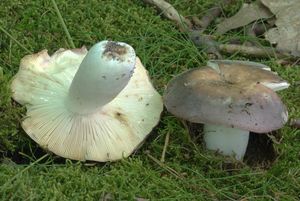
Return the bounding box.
[164,60,289,160]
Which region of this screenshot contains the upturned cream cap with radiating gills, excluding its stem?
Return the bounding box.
[11,47,163,161]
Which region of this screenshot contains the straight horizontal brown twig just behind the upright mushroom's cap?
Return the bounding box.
[219,44,291,58]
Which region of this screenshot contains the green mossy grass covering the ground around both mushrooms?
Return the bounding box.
[0,0,300,200]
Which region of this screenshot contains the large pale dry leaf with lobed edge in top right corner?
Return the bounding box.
[261,0,300,56]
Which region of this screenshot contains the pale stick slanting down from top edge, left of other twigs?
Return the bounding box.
[144,0,192,30]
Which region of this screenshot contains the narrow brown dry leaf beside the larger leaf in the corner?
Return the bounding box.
[216,1,273,34]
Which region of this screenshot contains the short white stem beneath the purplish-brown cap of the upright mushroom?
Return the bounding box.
[203,124,249,160]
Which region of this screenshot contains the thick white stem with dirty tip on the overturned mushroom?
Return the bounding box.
[66,41,136,114]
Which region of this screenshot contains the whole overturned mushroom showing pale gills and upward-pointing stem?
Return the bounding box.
[11,41,163,162]
